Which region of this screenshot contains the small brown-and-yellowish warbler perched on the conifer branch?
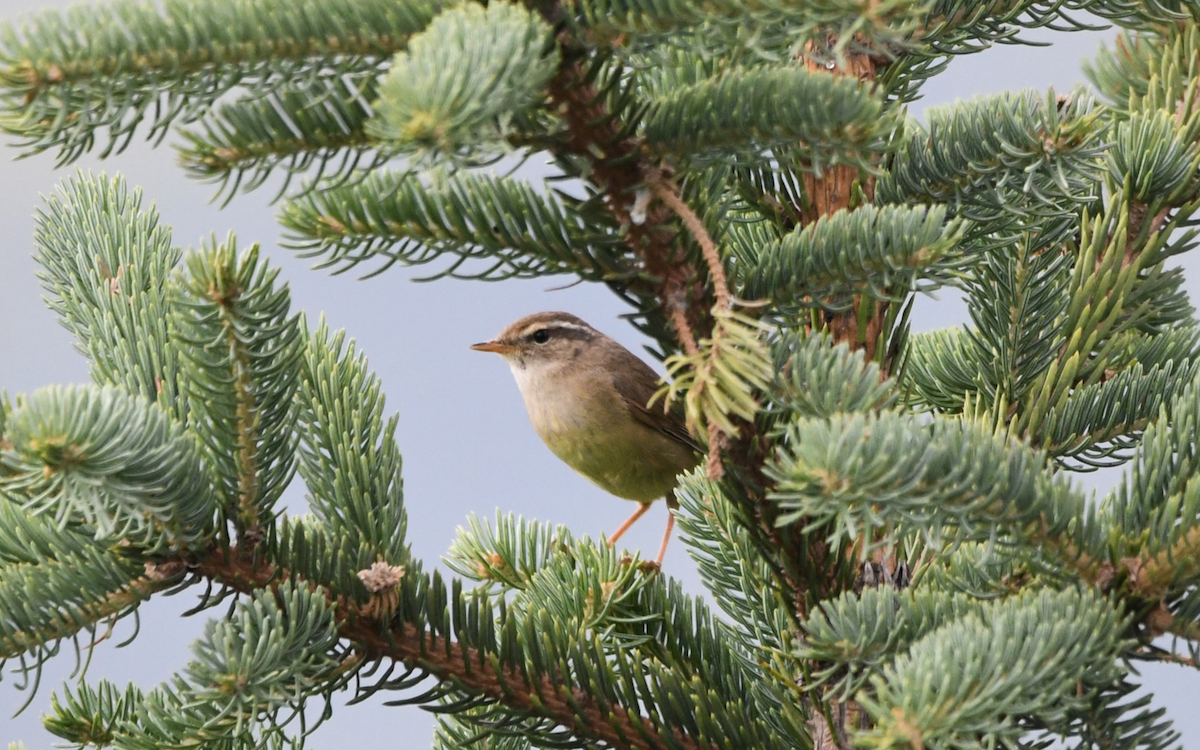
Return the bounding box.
[472,312,703,565]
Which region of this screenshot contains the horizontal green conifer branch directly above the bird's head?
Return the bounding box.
[280,169,634,282]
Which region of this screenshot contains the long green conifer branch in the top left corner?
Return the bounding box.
[0,0,443,163]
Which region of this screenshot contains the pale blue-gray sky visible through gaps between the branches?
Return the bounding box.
[0,0,1200,750]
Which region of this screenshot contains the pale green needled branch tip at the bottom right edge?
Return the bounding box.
[859,589,1124,749]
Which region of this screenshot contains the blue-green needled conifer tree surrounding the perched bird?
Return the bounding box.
[0,0,1200,750]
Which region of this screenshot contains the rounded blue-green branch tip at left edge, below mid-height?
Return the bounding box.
[0,386,214,554]
